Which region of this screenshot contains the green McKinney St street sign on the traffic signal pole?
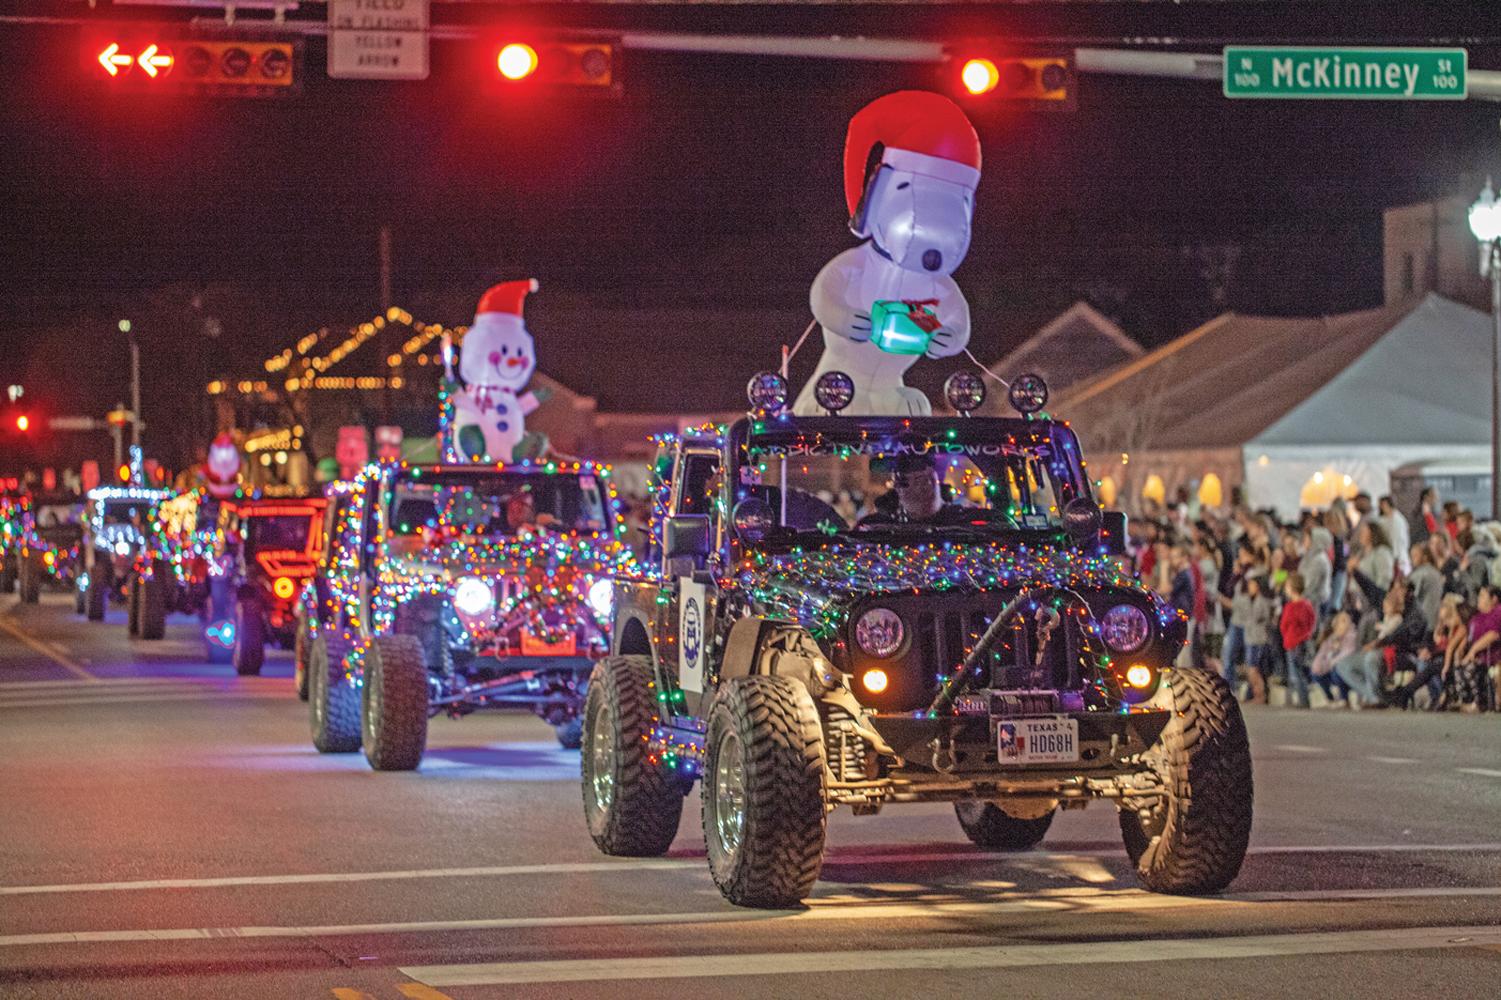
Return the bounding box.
[1225,45,1469,101]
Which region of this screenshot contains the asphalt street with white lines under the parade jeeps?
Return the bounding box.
[0,595,1501,1000]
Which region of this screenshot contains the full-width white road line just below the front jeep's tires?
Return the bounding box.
[0,886,1501,948]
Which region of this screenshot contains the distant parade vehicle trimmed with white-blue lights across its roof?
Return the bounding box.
[78,485,173,622]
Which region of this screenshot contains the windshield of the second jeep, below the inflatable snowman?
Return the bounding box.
[389,468,606,541]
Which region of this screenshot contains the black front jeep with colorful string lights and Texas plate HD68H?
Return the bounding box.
[582,372,1252,907]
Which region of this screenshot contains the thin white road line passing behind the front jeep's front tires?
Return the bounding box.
[11,841,1501,896]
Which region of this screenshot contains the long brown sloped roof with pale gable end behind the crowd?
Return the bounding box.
[1054,294,1490,450]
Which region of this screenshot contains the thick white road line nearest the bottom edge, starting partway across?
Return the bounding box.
[401,926,1501,986]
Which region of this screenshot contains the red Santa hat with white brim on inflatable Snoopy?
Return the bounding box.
[845,90,980,216]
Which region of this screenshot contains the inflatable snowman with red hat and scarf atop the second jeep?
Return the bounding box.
[443,279,545,462]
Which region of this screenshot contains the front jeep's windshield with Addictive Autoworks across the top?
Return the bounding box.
[732,417,1088,544]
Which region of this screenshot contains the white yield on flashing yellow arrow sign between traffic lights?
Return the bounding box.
[329,0,429,80]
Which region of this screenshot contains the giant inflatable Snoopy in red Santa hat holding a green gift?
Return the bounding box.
[793,90,980,416]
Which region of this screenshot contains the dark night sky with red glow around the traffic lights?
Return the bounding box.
[0,3,1501,465]
